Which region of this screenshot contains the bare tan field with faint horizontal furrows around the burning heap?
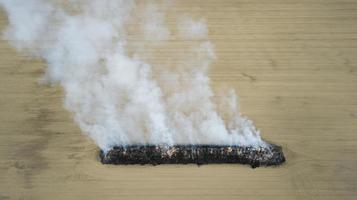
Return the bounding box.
[0,0,357,200]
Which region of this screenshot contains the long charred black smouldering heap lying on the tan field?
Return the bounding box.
[100,141,285,168]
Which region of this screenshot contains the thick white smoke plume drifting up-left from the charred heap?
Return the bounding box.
[0,0,264,151]
